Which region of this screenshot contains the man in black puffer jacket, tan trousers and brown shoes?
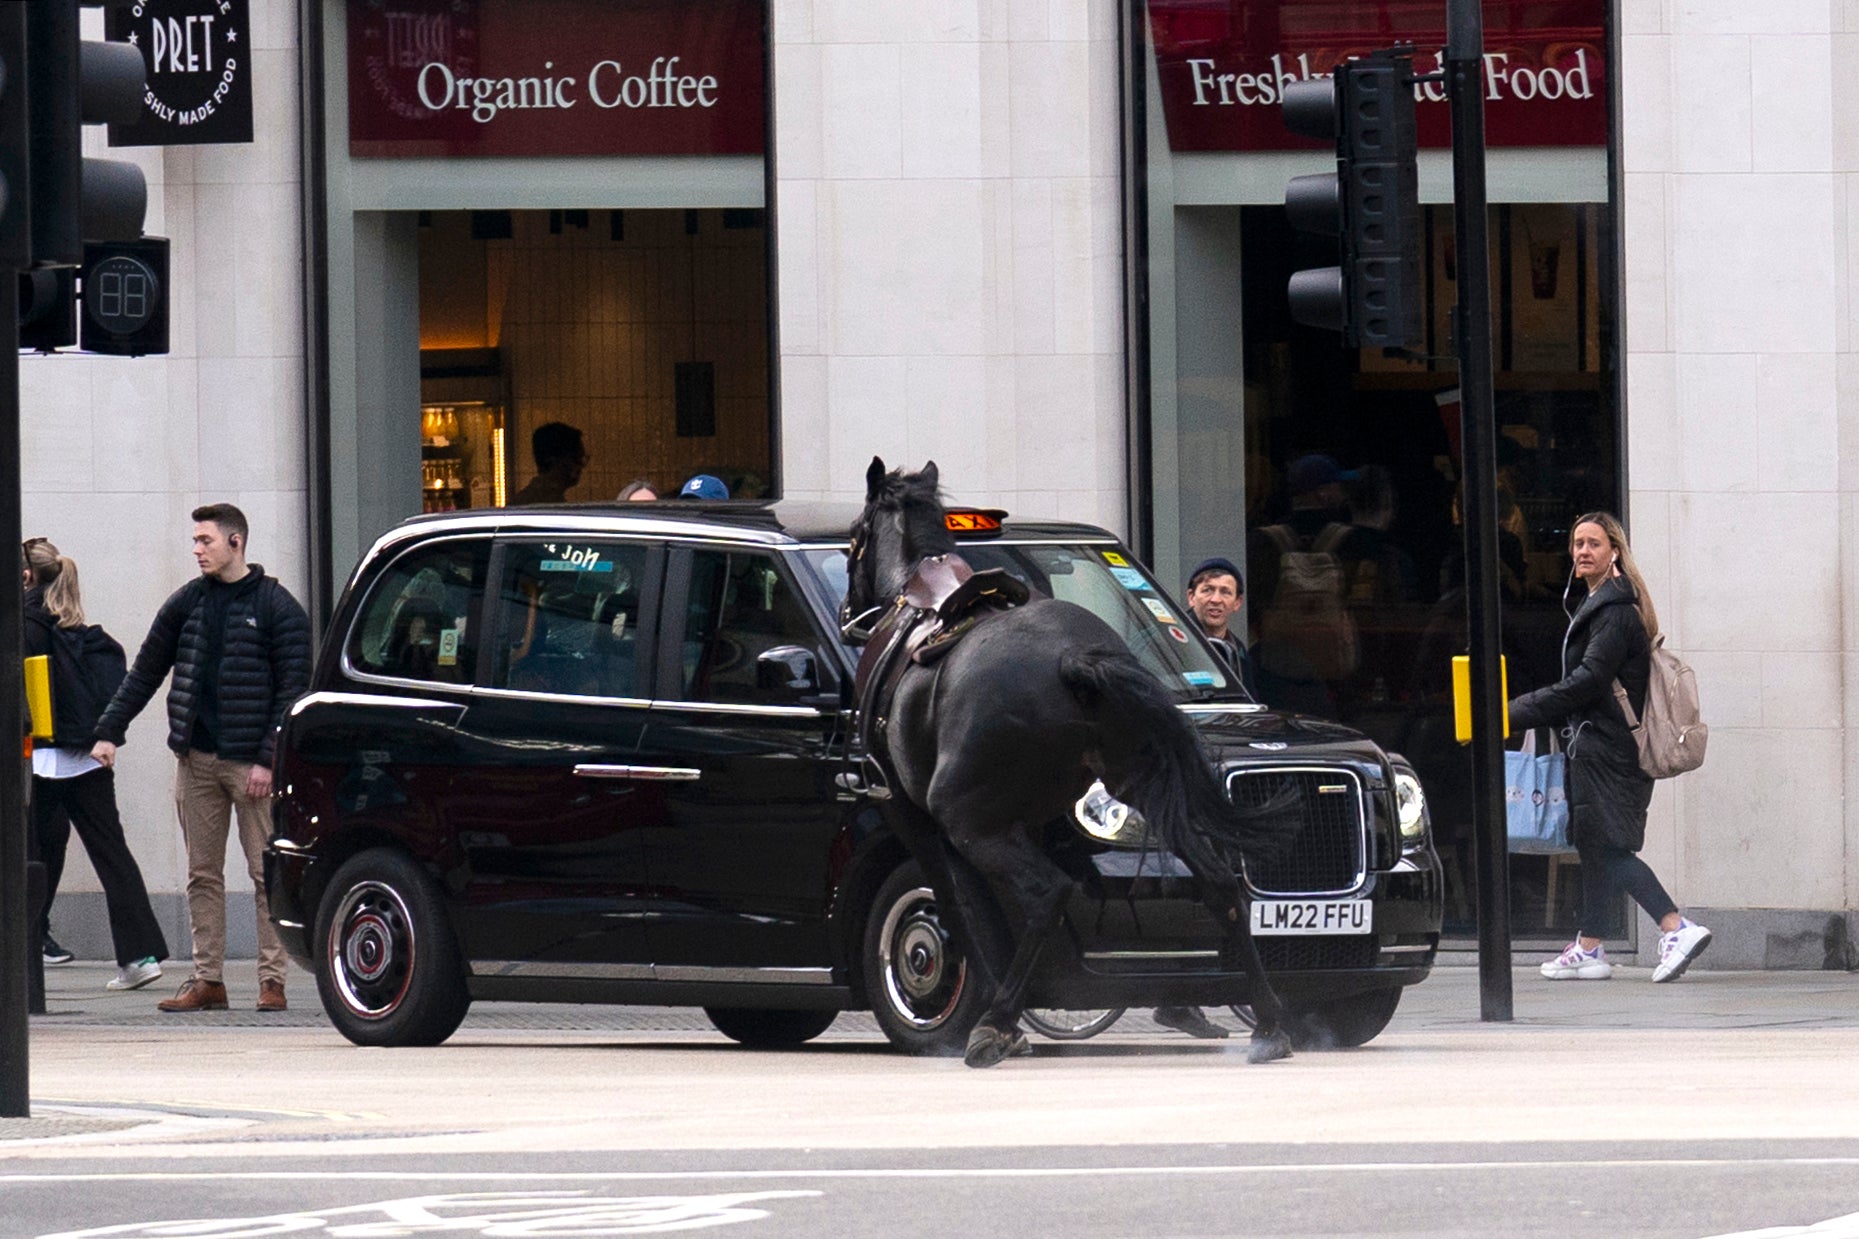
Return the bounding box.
[91,504,310,1010]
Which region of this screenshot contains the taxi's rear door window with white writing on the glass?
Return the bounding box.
[491,540,647,698]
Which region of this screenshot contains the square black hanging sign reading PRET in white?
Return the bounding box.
[104,0,251,147]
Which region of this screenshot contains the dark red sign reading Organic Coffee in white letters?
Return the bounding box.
[348,0,766,156]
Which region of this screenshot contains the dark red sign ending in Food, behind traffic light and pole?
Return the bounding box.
[1149,0,1608,151]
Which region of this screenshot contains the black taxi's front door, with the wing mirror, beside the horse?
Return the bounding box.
[638,545,855,984]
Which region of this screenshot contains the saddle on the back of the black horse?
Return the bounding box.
[853,554,1032,752]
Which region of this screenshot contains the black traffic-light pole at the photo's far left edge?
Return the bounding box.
[0,268,39,1118]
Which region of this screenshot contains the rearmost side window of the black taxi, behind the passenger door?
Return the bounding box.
[348,538,491,685]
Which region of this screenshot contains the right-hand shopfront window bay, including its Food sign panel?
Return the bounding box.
[1130,0,1625,939]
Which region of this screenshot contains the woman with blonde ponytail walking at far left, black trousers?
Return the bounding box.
[22,538,167,990]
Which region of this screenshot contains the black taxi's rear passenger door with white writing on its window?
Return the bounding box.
[440,534,664,980]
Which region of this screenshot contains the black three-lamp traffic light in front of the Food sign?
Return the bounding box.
[1285,50,1422,348]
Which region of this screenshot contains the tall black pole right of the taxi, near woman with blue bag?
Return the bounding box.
[1446,0,1511,1019]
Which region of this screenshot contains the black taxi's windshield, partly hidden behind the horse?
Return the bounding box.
[791,541,1246,701]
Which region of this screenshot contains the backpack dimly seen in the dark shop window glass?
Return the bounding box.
[1259,521,1357,681]
